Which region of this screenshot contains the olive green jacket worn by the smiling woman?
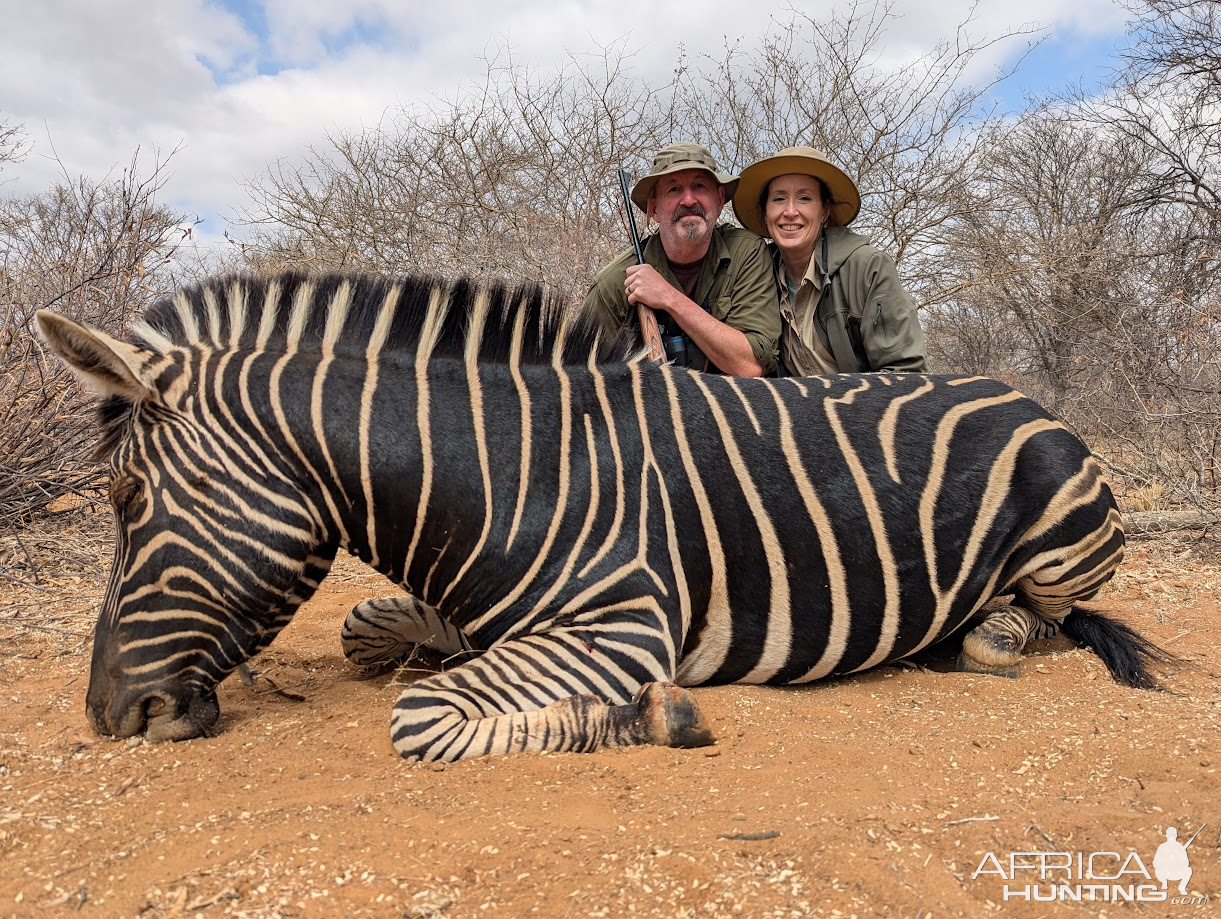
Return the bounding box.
[775,227,928,375]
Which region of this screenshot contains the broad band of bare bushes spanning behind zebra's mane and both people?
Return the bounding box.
[235,6,1026,312]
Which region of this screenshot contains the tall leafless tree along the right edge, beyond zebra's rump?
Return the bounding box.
[1072,0,1221,511]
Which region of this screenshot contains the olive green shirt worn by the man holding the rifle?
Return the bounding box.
[582,223,780,373]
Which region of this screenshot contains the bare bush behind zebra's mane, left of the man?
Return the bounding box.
[238,38,664,297]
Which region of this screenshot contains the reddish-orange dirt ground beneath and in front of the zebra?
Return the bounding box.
[0,514,1221,919]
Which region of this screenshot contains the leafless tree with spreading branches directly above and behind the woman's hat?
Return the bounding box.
[676,2,1042,304]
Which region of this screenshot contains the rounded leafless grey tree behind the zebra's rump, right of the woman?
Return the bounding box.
[934,106,1142,390]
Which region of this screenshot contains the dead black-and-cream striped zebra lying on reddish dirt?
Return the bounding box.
[37,272,1159,760]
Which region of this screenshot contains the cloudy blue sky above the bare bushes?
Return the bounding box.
[0,0,1126,255]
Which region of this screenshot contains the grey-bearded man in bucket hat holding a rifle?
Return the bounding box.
[584,143,780,376]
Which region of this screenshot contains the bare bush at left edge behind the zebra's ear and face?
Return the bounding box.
[0,153,186,526]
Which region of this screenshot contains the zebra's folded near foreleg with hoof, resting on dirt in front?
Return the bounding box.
[391,635,714,762]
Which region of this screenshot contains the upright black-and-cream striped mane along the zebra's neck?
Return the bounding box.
[132,272,630,366]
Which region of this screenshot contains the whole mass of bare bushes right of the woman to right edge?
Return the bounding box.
[926,0,1221,513]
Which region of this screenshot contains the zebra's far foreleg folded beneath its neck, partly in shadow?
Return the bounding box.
[339,594,470,666]
